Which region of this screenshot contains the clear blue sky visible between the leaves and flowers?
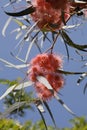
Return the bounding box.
[0,2,87,127]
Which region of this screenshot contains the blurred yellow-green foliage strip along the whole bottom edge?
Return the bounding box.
[0,117,87,130]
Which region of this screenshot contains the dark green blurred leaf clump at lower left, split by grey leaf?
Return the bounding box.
[3,90,33,116]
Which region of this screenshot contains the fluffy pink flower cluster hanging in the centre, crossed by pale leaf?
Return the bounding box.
[29,53,64,100]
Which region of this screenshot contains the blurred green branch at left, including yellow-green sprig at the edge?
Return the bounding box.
[0,78,33,116]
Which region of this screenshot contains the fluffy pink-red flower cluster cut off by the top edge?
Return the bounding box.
[31,0,70,31]
